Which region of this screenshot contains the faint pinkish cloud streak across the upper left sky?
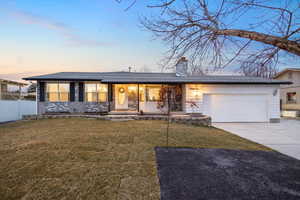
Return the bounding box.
[11,10,109,47]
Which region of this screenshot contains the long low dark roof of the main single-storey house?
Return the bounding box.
[24,72,291,84]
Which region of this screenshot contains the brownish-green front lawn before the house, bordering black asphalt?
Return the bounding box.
[0,119,270,200]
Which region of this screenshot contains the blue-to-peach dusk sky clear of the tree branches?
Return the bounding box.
[0,0,300,80]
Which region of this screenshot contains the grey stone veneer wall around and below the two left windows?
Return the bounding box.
[37,82,109,114]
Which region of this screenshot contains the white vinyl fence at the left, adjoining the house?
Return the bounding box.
[0,100,36,122]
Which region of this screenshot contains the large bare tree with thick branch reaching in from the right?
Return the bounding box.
[129,0,300,77]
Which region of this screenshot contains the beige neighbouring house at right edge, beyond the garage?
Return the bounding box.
[275,68,300,111]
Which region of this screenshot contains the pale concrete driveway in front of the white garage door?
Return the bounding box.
[213,119,300,160]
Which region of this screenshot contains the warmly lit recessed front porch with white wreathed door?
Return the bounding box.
[108,84,184,114]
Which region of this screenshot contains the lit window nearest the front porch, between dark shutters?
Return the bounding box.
[85,83,108,102]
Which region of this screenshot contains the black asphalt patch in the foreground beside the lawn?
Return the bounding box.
[155,147,300,200]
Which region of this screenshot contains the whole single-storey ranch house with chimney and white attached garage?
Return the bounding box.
[24,58,290,122]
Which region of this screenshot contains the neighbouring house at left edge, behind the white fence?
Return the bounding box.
[0,79,27,100]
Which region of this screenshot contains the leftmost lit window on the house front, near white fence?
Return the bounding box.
[47,83,70,102]
